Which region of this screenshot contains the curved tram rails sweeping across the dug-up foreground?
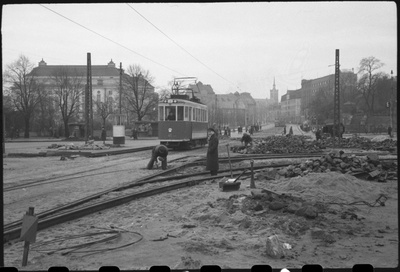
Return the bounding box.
[3,153,396,242]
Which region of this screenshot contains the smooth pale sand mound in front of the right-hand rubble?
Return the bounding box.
[271,172,382,203]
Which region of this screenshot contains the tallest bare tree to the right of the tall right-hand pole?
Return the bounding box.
[358,57,384,118]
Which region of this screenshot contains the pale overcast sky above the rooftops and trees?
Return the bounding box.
[2,1,397,98]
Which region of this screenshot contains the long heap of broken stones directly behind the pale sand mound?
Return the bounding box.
[256,151,397,182]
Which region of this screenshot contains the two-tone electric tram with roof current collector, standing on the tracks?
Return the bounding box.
[158,78,208,149]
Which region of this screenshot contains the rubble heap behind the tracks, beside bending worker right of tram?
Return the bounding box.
[231,135,321,154]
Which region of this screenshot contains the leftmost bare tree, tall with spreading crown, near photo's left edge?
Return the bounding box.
[4,55,43,138]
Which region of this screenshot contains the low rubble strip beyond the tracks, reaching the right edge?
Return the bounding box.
[314,136,397,152]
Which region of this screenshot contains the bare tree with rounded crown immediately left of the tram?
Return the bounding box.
[123,65,158,121]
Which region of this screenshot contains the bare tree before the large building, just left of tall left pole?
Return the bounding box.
[51,67,85,137]
